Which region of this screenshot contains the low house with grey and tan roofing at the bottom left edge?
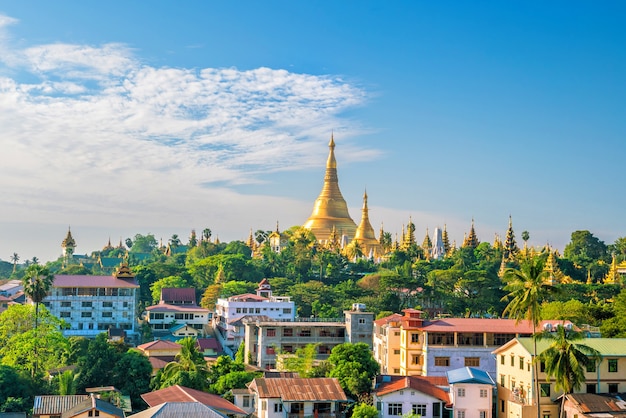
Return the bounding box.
[32,395,124,418]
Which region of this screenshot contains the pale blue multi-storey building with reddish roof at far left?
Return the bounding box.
[43,265,139,337]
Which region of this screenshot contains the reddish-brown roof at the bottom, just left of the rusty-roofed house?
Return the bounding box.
[141,385,246,415]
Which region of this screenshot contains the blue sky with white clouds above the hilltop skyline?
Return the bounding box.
[0,0,626,261]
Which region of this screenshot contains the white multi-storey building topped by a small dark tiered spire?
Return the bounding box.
[213,279,296,351]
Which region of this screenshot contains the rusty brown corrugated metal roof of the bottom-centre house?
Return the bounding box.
[249,377,348,402]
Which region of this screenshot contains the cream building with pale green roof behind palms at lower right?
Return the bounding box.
[493,336,626,418]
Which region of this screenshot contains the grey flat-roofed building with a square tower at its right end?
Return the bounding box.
[244,304,374,370]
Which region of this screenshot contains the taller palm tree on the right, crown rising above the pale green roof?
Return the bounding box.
[502,257,552,418]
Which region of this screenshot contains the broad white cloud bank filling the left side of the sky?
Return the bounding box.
[0,15,377,258]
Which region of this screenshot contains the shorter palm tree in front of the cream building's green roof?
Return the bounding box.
[535,325,601,416]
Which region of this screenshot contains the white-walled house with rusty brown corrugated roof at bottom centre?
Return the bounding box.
[244,377,348,418]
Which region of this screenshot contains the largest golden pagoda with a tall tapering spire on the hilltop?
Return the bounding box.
[303,135,357,242]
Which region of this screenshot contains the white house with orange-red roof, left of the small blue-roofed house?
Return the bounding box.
[372,375,451,418]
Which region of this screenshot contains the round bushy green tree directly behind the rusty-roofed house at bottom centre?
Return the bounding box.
[328,343,380,399]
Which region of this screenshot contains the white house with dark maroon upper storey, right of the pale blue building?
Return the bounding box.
[146,288,212,336]
